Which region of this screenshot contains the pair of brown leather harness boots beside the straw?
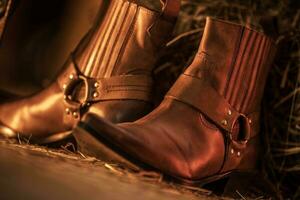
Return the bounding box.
[0,0,275,191]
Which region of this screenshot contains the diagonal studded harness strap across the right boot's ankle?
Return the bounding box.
[166,74,259,140]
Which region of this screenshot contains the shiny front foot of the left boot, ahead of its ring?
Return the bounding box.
[0,82,67,137]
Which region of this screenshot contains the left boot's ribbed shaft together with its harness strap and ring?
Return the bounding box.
[58,0,180,124]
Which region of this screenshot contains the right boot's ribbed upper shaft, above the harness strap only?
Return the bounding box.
[185,18,275,113]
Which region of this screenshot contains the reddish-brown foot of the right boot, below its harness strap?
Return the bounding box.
[103,100,224,179]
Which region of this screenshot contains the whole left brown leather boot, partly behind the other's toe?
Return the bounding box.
[0,0,180,143]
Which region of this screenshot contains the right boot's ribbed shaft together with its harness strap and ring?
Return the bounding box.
[166,18,276,146]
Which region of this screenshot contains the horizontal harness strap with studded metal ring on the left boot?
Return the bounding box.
[58,55,153,104]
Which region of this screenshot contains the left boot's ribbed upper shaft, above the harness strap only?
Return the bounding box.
[75,0,179,78]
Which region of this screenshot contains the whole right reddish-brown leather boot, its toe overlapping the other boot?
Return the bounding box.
[74,18,275,184]
